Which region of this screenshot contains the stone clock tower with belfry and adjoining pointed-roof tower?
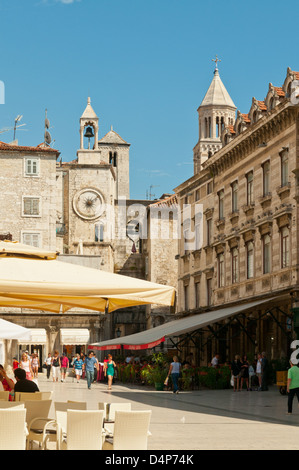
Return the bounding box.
[61,98,130,272]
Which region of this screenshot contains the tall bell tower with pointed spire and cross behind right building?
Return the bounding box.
[193,55,237,174]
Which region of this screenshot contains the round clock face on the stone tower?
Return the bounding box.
[73,189,104,220]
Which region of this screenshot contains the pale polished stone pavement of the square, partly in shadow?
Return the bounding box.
[31,374,299,451]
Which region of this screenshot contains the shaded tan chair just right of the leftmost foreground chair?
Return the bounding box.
[25,400,52,449]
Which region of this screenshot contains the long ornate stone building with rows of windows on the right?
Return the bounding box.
[176,69,299,364]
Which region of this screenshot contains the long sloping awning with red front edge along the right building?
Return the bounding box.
[88,299,273,350]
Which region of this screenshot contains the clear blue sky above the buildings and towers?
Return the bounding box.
[0,0,299,199]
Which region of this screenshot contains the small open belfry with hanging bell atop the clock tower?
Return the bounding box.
[77,98,101,165]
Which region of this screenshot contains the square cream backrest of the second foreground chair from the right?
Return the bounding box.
[67,410,104,450]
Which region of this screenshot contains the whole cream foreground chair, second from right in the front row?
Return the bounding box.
[56,410,104,450]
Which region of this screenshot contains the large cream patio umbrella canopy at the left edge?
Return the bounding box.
[0,241,175,313]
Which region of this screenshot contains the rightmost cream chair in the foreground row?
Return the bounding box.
[103,410,152,450]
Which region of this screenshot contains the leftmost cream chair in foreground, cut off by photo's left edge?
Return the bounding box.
[0,408,27,450]
